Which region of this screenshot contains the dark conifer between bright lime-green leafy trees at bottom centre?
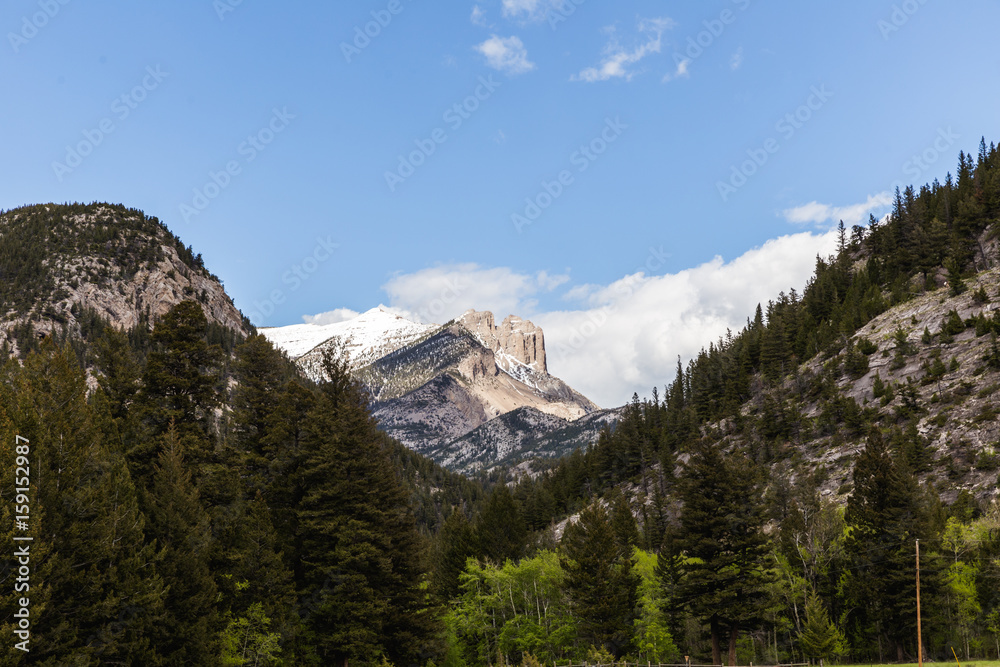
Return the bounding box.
[561,503,639,658]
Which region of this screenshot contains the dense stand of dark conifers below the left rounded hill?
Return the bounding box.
[0,301,481,665]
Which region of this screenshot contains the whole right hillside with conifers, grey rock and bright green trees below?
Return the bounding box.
[424,141,1000,664]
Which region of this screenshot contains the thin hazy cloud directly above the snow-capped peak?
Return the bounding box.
[382,264,569,324]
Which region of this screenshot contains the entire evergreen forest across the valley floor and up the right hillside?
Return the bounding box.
[0,141,1000,667]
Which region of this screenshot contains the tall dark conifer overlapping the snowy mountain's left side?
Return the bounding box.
[298,354,435,665]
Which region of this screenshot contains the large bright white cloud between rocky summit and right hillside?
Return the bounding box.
[531,232,836,407]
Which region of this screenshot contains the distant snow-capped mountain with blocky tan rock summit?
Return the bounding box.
[261,307,600,472]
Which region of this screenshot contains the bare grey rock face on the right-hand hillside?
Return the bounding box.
[783,269,1000,501]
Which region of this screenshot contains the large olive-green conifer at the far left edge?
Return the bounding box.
[0,340,164,665]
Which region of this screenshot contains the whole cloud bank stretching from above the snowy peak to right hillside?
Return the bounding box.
[352,230,836,407]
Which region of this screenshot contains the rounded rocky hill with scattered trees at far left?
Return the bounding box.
[0,204,252,349]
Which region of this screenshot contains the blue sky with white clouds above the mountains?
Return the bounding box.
[0,0,1000,404]
